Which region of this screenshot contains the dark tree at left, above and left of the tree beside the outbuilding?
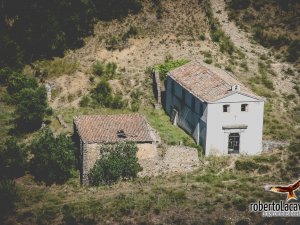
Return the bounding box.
[15,87,49,131]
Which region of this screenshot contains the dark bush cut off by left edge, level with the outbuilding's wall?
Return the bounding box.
[0,138,27,179]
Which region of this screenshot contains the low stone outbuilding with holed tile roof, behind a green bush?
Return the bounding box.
[74,114,156,184]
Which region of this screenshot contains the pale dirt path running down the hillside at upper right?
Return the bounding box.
[210,0,294,94]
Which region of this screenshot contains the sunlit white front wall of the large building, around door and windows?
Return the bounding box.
[205,93,264,155]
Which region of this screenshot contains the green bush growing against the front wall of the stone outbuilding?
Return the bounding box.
[89,143,142,185]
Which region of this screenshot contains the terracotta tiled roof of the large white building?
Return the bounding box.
[168,61,260,102]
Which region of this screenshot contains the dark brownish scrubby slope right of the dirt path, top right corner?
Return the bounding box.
[226,0,300,64]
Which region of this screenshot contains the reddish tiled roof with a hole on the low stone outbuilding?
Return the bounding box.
[74,114,153,143]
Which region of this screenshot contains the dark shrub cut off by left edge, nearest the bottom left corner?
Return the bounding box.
[0,179,19,222]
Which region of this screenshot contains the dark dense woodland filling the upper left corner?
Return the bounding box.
[0,0,142,68]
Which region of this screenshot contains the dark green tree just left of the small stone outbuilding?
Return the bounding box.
[30,129,75,184]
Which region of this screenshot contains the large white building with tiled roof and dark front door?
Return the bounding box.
[166,61,264,155]
